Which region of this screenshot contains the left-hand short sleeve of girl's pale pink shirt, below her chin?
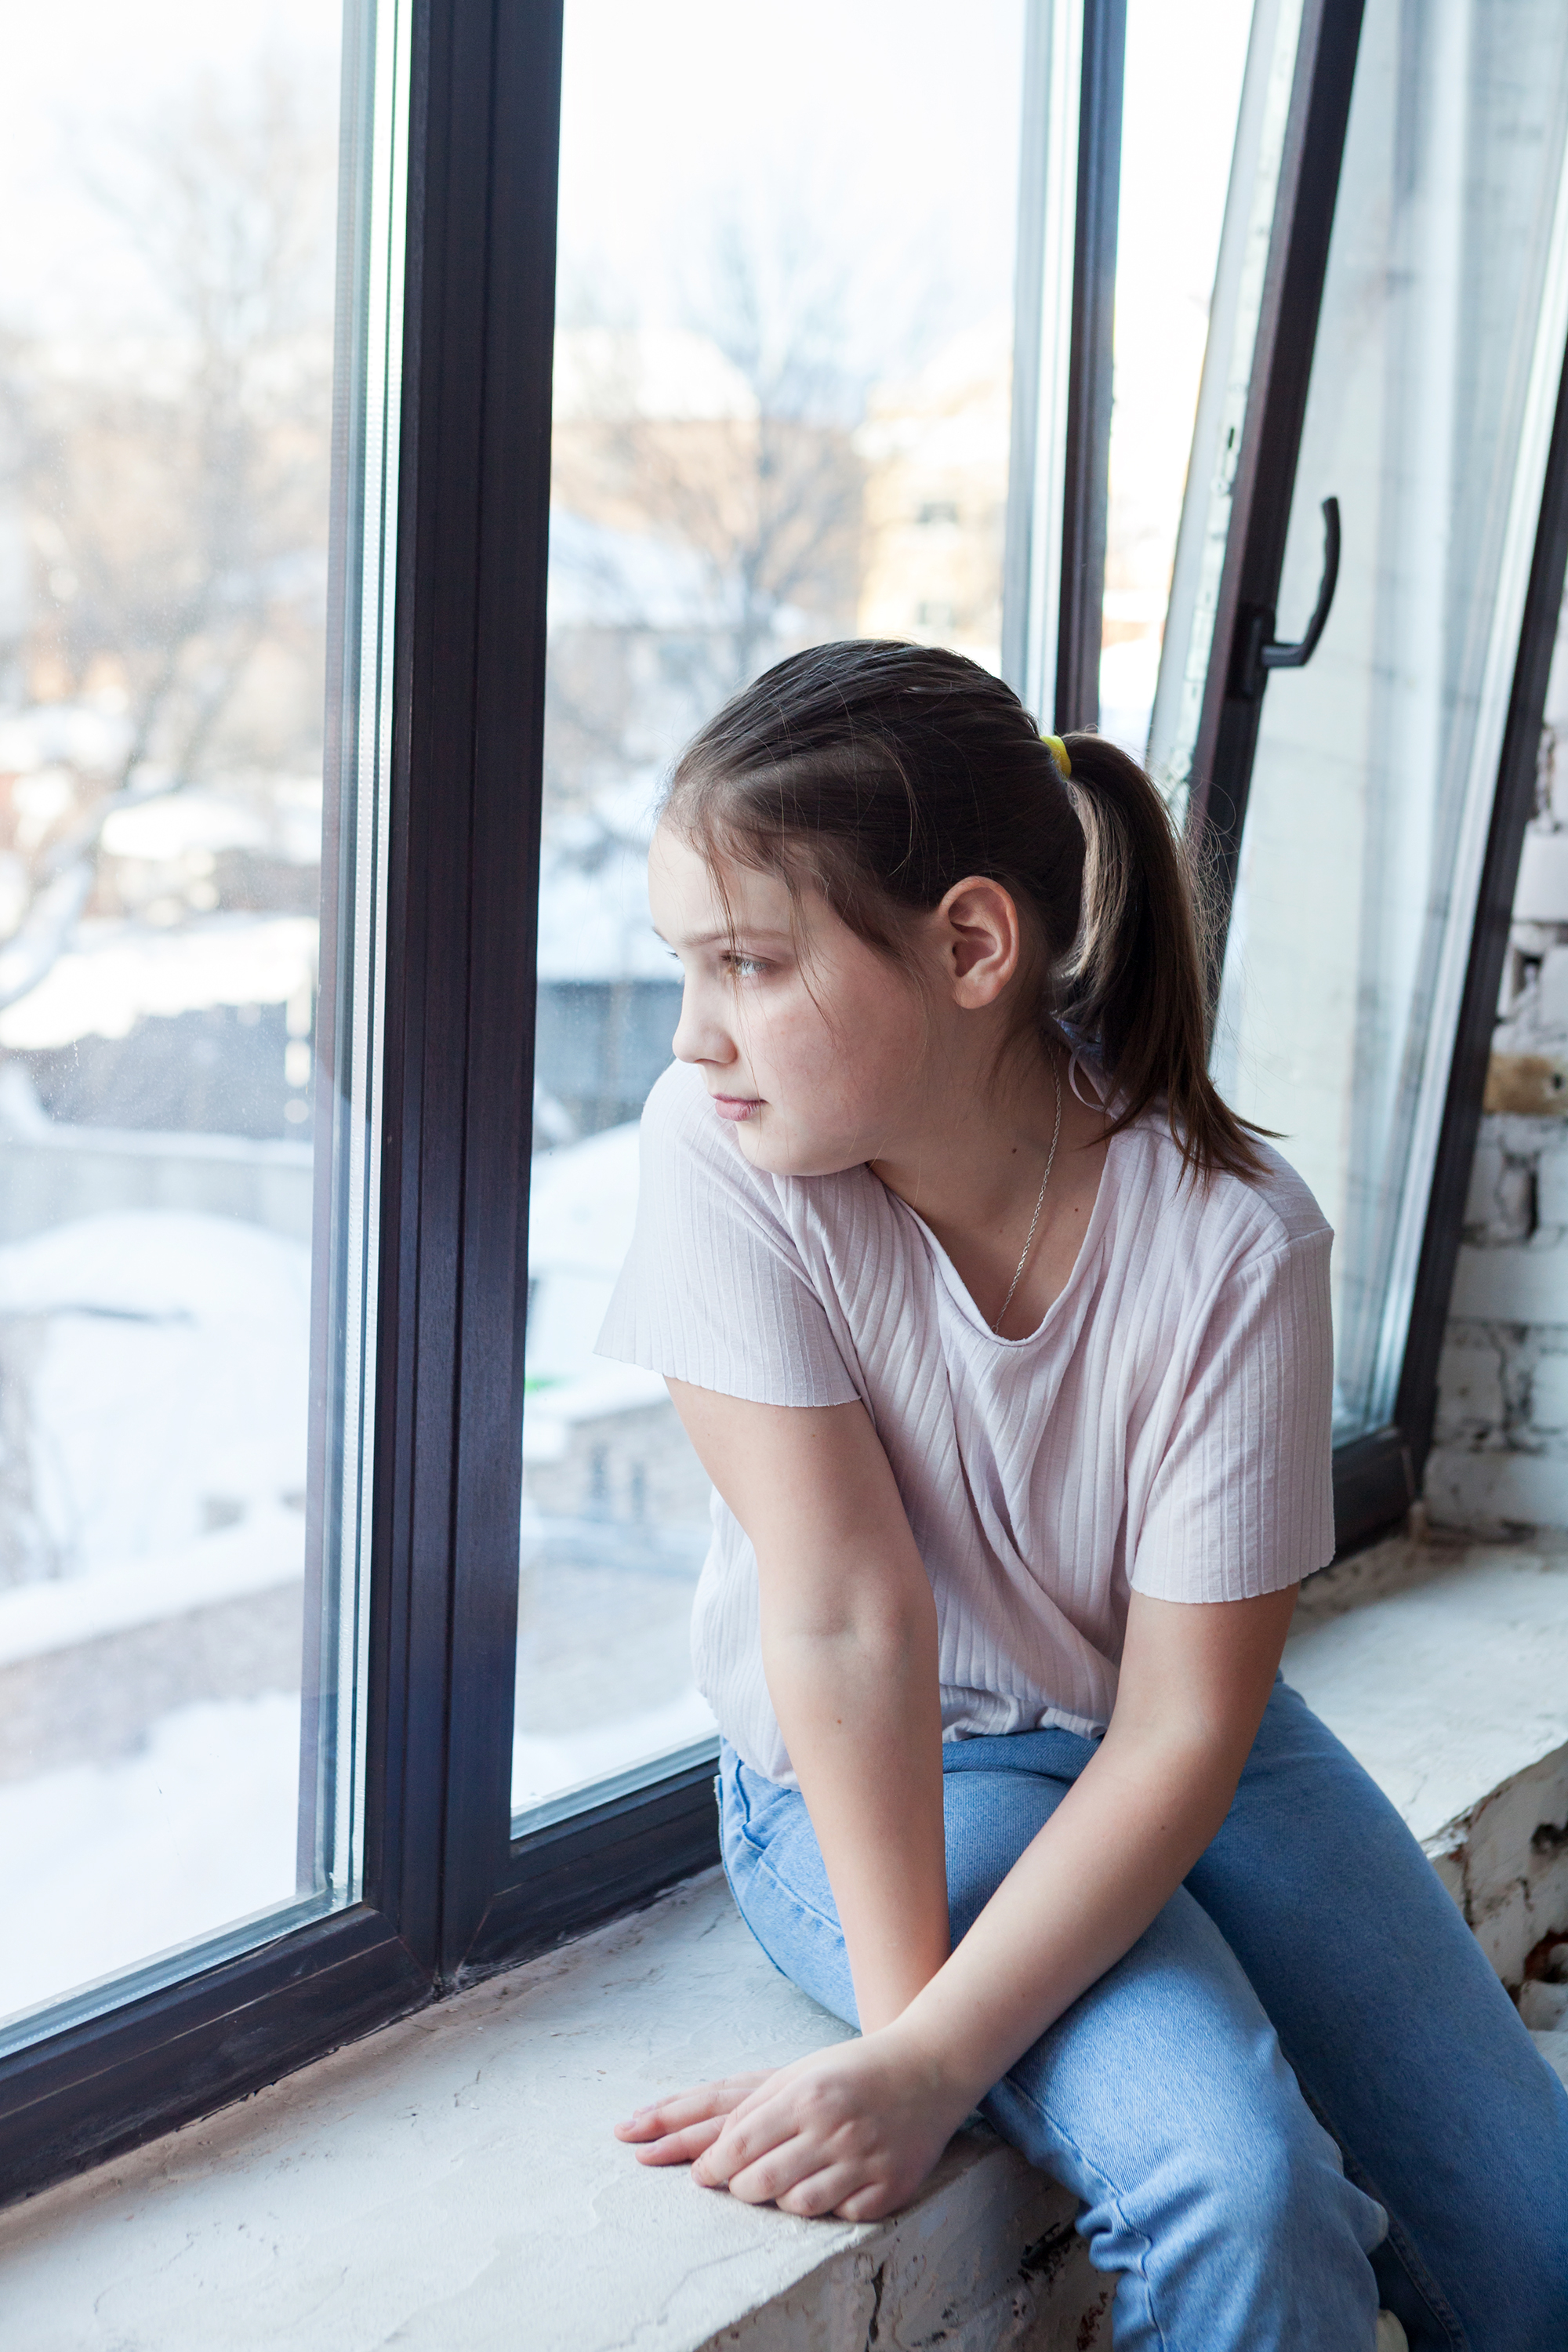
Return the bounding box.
[595,1063,860,1404]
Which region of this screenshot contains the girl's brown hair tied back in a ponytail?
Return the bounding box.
[663,637,1260,1176]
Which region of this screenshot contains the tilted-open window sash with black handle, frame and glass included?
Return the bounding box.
[1152,0,1568,1541]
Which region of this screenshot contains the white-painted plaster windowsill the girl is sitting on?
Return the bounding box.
[0,1548,1568,2352]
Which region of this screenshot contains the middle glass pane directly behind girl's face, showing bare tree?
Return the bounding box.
[515,0,1022,1820]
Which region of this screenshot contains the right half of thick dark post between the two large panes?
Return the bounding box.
[440,0,562,1976]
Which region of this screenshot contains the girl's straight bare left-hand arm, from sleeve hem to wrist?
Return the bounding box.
[670,1381,947,2032]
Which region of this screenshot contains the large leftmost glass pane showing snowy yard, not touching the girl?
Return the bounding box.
[0,0,407,2039]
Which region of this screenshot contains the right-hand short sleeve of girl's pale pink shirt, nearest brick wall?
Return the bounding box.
[1128,1228,1333,1602]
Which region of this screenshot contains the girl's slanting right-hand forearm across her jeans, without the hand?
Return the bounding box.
[893,1726,1236,2124]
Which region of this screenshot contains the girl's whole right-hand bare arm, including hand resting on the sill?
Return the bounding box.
[626,1392,1295,2220]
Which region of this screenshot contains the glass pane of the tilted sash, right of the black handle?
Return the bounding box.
[1218,0,1568,1435]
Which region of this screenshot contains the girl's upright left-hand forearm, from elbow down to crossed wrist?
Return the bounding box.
[764,1592,949,2032]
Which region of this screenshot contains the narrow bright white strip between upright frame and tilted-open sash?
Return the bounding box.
[1100,0,1274,760]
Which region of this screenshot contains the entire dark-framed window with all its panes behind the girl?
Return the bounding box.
[0,0,1568,2194]
